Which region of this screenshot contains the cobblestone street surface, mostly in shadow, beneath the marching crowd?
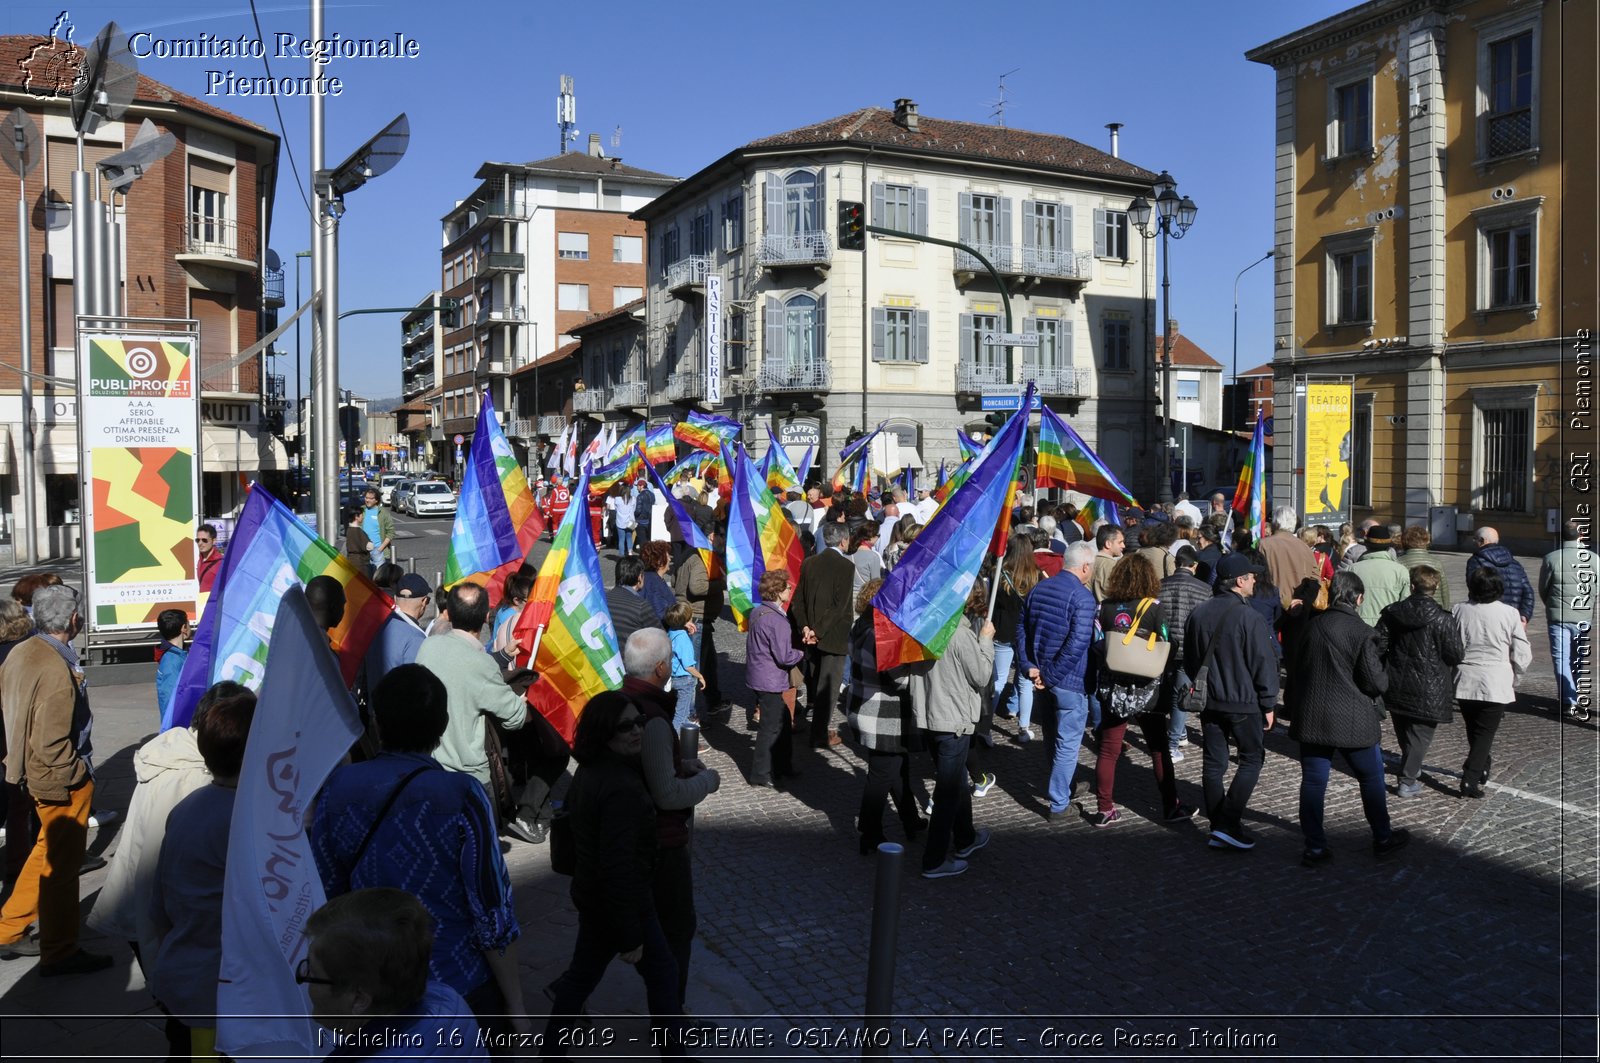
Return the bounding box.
[0,544,1600,1058]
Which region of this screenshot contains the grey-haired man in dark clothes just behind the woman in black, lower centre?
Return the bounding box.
[622,628,722,1007]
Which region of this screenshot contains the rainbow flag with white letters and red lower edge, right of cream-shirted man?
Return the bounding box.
[515,469,622,744]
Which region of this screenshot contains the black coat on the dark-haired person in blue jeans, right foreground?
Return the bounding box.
[1290,605,1389,749]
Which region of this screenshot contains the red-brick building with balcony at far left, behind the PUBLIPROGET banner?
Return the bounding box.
[0,37,286,557]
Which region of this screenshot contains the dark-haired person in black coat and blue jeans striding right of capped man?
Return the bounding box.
[1290,572,1411,868]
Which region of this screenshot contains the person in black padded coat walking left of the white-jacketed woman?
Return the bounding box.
[1378,565,1466,797]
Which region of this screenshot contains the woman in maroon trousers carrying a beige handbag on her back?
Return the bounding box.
[1090,554,1195,828]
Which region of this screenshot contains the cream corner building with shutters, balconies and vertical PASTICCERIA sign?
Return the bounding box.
[624,99,1158,491]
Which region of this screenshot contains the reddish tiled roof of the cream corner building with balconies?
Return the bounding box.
[742,107,1155,181]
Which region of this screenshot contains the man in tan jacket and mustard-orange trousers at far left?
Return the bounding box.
[0,586,112,978]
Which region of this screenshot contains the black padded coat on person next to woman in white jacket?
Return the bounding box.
[1378,594,1466,724]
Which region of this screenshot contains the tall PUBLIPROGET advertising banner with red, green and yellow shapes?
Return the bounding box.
[78,331,200,631]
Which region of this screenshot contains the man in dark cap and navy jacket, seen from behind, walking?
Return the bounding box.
[1184,554,1278,848]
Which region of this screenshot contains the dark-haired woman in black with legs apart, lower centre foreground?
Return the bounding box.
[544,692,683,1057]
